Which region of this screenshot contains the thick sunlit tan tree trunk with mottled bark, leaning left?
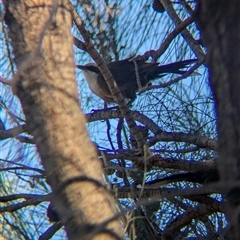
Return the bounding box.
[4,0,124,239]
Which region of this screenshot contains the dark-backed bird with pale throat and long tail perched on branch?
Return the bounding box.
[76,58,197,103]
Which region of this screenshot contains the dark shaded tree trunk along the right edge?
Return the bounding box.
[196,0,240,240]
